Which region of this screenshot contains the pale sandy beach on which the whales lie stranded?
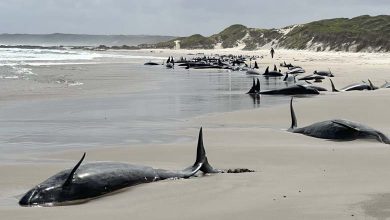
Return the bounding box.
[0,50,390,220]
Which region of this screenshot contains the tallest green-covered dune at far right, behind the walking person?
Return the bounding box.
[280,15,390,52]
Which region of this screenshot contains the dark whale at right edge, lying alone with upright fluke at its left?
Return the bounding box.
[289,98,390,144]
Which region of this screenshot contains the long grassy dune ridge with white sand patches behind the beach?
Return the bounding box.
[153,15,390,52]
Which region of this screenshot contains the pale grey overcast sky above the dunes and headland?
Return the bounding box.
[0,0,390,36]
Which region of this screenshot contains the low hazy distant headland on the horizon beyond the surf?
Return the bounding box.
[0,33,176,46]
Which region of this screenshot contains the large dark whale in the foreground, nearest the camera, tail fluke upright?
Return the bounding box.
[19,129,221,206]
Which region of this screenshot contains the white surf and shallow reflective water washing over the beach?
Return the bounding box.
[0,49,288,162]
